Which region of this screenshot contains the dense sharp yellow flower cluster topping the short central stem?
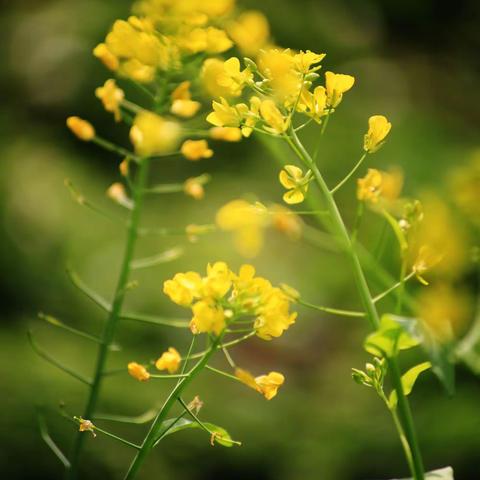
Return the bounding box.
[167,262,297,340]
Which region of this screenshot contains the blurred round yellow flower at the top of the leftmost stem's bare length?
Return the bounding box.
[130,111,180,156]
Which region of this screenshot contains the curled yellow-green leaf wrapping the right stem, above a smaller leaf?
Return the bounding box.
[364,314,421,358]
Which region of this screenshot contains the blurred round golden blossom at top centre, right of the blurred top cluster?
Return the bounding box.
[227,10,270,56]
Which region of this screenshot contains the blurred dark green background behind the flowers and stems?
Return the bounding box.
[0,0,480,480]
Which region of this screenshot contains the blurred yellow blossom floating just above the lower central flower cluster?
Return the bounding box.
[215,200,268,258]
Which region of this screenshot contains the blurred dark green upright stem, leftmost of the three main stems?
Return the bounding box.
[66,158,148,480]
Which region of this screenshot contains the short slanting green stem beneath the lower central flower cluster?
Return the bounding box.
[125,334,223,480]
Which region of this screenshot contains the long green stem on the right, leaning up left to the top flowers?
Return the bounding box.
[285,129,425,480]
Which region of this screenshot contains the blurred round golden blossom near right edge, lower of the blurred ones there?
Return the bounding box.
[417,283,471,343]
